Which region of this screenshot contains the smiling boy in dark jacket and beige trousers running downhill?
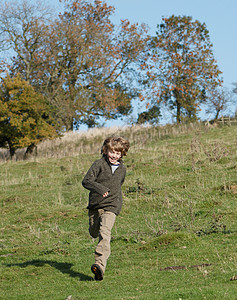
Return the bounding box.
[82,136,129,280]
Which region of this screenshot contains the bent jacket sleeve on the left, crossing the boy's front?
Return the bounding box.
[82,162,109,195]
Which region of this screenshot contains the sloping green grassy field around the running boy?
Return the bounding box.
[0,124,237,300]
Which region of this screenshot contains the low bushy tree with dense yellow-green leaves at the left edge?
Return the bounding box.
[0,75,58,158]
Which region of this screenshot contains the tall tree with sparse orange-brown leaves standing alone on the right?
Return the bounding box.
[151,15,221,123]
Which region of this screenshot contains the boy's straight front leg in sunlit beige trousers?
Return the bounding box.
[95,209,116,274]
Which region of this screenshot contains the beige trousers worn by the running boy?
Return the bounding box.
[88,209,116,273]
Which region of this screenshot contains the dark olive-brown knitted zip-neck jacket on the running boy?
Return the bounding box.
[82,155,126,215]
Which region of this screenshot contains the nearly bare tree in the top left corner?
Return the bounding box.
[0,0,52,81]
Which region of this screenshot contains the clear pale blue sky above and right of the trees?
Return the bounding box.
[49,0,237,124]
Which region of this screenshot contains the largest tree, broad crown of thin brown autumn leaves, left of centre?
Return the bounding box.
[0,0,148,130]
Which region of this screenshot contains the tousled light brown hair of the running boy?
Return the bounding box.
[101,136,130,157]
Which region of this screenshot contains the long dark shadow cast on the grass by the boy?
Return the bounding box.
[7,260,94,281]
